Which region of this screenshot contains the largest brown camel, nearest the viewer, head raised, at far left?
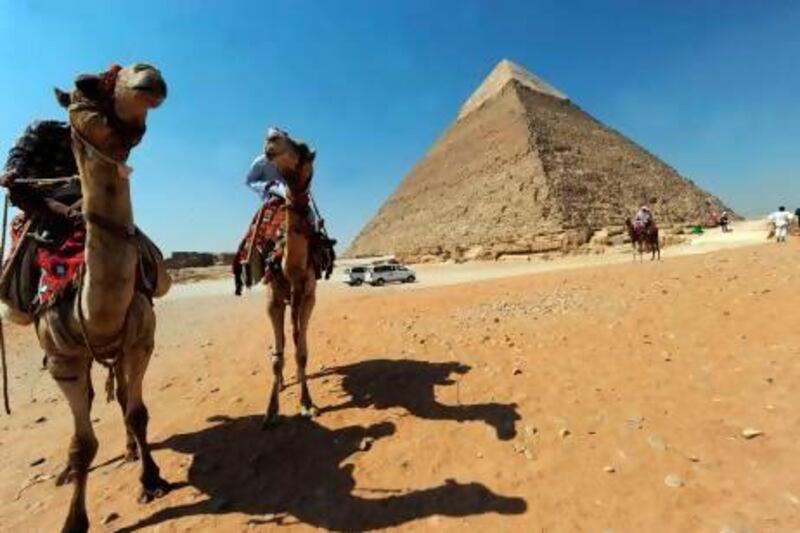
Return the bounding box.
[36,64,170,532]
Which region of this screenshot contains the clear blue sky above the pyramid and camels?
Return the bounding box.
[0,0,800,251]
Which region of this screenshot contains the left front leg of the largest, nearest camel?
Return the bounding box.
[47,355,98,533]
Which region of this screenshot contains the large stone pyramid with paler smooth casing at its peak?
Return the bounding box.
[345,60,730,260]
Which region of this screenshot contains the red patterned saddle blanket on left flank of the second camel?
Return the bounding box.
[233,196,286,285]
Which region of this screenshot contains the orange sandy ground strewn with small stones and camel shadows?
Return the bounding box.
[0,221,800,532]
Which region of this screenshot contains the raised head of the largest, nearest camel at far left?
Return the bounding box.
[55,63,167,161]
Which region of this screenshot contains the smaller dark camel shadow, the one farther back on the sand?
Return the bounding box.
[311,359,520,440]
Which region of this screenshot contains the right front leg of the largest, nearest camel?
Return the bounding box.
[121,345,170,503]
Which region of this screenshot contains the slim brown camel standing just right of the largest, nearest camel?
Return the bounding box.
[263,132,318,427]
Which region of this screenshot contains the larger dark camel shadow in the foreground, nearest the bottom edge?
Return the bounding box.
[114,416,527,532]
